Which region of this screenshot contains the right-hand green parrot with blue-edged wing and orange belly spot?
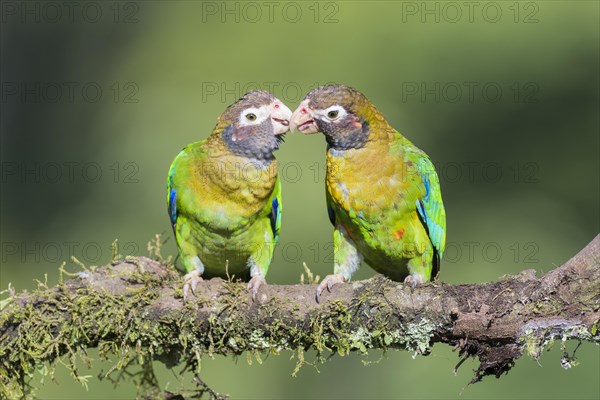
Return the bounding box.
[290,85,446,301]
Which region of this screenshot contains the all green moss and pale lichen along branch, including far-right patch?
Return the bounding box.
[14,237,600,398]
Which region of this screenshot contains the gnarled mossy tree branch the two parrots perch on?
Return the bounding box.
[0,235,600,397]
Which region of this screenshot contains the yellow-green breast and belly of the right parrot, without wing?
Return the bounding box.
[326,131,442,280]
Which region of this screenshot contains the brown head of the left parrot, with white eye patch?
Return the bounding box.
[214,90,292,159]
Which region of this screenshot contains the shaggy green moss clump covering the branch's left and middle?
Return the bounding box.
[0,266,435,398]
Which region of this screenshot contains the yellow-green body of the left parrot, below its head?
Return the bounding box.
[167,141,280,277]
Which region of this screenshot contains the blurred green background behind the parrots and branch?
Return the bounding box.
[0,1,600,399]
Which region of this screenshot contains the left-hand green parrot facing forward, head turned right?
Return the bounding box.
[167,90,292,301]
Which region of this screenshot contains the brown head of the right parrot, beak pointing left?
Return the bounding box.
[290,84,386,150]
